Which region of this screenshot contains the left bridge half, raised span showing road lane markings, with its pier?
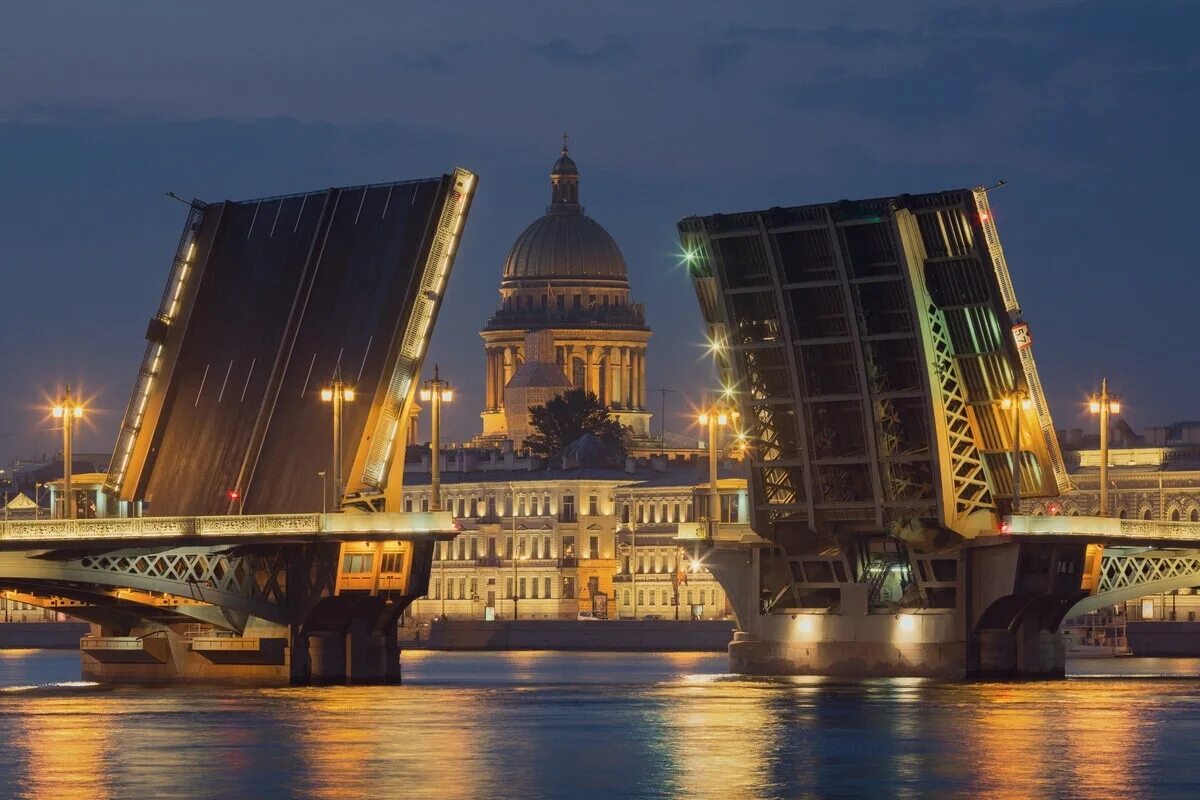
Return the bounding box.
[0,169,476,682]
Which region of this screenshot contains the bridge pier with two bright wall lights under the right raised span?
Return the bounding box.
[704,540,1085,680]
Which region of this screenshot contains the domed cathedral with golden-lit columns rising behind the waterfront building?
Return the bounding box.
[480,143,650,447]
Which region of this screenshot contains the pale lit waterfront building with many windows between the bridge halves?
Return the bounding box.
[403,446,748,620]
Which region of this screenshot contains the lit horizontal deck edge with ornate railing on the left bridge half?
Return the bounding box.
[0,512,458,551]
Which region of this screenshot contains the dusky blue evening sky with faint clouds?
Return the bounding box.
[0,0,1200,462]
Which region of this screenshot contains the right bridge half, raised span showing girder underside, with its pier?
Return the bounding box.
[678,187,1200,676]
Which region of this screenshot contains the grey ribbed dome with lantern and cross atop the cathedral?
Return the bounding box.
[504,144,629,282]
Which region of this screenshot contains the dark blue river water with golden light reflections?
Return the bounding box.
[0,650,1200,800]
